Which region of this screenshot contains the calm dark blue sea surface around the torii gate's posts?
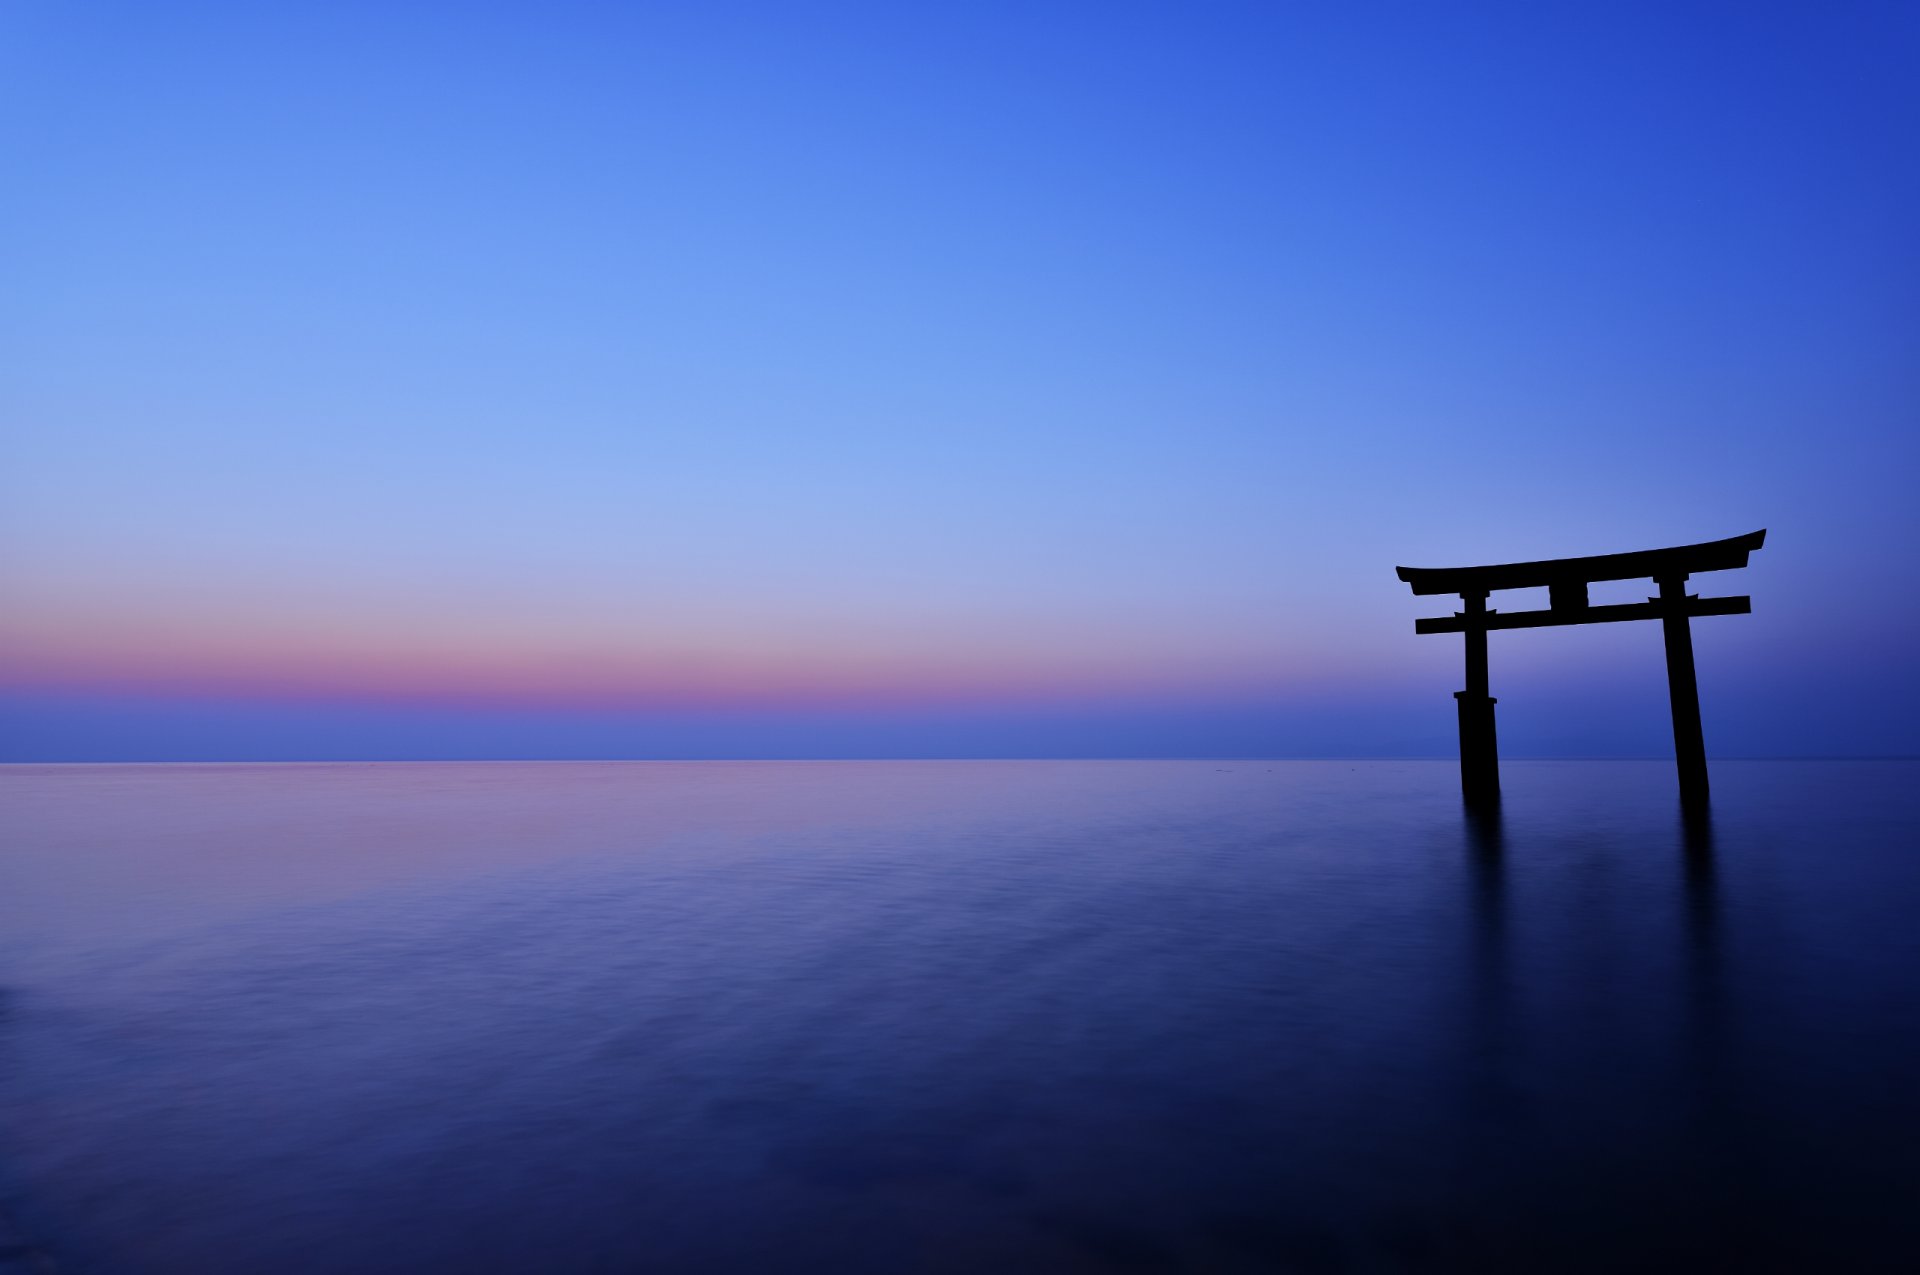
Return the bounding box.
[0,762,1920,1275]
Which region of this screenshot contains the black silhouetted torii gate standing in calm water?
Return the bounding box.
[1394,528,1766,803]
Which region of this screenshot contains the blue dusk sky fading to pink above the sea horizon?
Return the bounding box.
[0,0,1920,760]
